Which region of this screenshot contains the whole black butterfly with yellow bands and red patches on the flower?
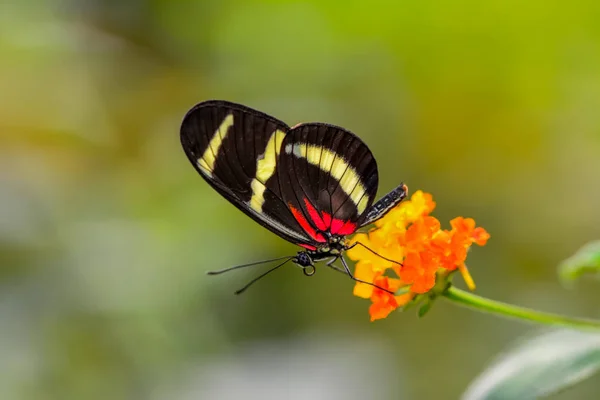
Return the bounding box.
[180,100,408,294]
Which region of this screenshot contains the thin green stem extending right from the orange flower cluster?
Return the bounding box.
[442,286,600,330]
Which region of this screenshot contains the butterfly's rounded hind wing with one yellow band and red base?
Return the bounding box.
[277,123,379,242]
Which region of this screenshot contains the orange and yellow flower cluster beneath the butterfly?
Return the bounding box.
[348,190,490,321]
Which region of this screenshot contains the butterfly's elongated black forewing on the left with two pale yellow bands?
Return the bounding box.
[180,101,314,244]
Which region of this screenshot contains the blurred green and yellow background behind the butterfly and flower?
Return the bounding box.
[0,0,600,400]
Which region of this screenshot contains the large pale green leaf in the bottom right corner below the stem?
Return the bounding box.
[462,330,600,400]
